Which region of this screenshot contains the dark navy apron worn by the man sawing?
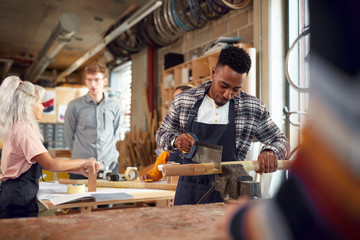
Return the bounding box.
[174,90,238,205]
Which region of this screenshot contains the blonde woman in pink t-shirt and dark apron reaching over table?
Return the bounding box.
[0,76,99,218]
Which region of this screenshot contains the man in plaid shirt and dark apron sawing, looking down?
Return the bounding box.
[156,47,290,205]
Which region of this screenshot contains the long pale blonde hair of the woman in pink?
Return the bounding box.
[0,76,45,141]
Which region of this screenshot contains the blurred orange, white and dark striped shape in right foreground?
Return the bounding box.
[217,0,360,240]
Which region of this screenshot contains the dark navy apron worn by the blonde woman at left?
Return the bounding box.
[0,163,42,218]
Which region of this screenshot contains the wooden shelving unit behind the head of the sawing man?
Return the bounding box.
[161,43,256,119]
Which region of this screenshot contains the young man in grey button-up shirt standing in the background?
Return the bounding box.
[64,63,120,179]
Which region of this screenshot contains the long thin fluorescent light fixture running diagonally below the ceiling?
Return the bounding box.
[57,0,162,82]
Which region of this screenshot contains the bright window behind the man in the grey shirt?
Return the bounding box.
[109,61,132,140]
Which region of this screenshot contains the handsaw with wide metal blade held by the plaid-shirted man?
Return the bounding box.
[182,133,223,169]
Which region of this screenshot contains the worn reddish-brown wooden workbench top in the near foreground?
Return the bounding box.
[0,203,225,240]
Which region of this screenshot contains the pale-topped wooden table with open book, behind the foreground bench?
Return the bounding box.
[38,183,175,213]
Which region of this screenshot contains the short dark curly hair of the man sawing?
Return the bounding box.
[216,46,251,73]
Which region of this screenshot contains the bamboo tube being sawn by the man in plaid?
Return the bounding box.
[162,160,292,177]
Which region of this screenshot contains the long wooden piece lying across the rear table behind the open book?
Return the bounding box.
[59,178,176,190]
